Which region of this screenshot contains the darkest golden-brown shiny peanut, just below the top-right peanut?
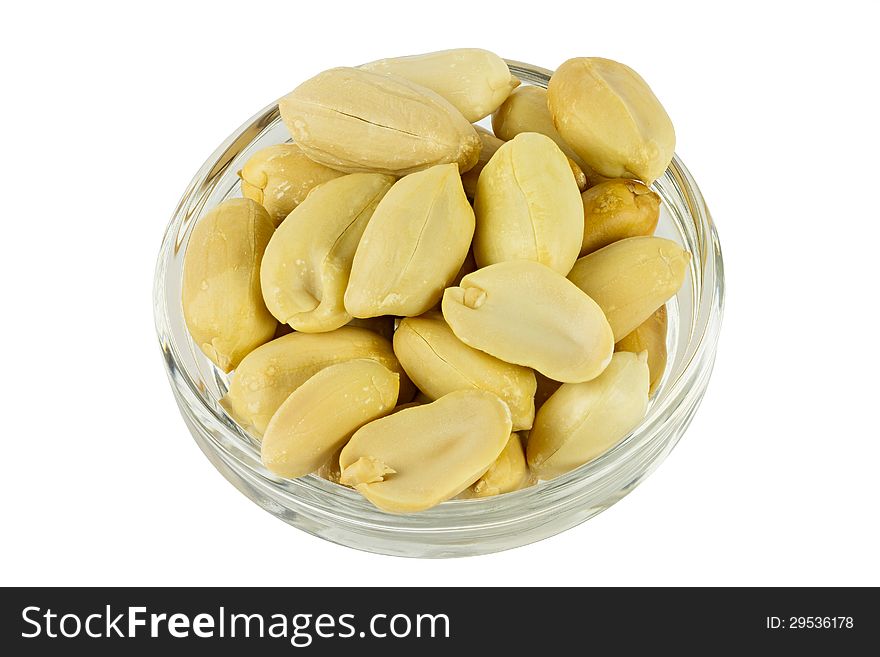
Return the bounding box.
[581,180,660,256]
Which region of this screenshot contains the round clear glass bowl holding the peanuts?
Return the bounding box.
[153,61,724,557]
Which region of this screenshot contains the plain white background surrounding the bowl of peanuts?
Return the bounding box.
[0,0,880,584]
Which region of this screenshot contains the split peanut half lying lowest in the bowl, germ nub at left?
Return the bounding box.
[339,390,511,513]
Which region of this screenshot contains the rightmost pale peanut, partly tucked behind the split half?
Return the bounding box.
[568,237,691,340]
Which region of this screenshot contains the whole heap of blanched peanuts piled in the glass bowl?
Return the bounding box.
[182,49,690,512]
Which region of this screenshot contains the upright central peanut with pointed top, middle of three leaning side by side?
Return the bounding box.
[345,164,474,317]
